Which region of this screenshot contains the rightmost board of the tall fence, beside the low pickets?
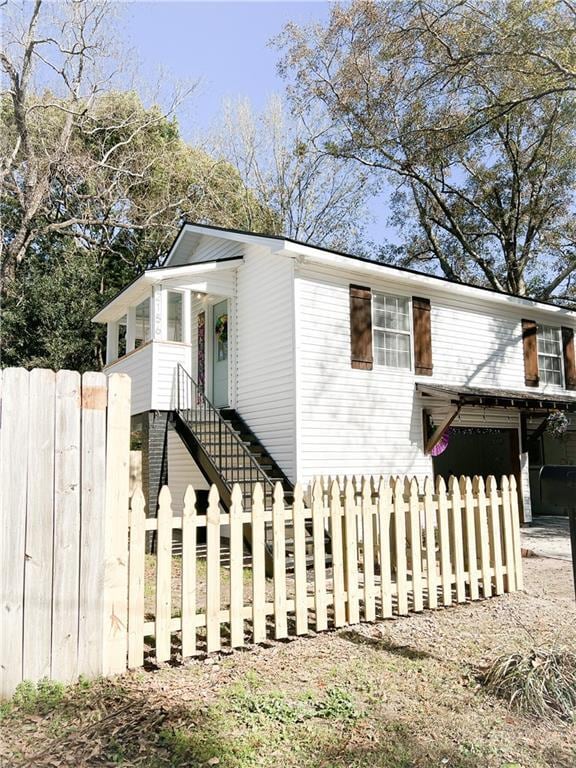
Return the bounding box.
[103,373,130,675]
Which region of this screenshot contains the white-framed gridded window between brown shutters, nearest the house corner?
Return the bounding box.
[372,293,411,369]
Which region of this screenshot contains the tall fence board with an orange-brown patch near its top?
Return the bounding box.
[78,372,107,677]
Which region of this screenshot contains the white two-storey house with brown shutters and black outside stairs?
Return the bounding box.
[94,224,576,520]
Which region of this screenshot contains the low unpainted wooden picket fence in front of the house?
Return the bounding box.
[127,477,522,667]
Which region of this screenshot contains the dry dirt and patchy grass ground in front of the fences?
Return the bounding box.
[0,558,576,768]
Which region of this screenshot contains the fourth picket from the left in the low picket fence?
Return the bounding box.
[206,485,222,653]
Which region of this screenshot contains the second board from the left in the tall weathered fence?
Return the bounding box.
[21,369,54,680]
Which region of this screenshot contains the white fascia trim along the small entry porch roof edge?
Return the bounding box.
[92,259,242,323]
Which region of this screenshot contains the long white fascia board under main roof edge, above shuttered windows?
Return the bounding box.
[278,242,576,323]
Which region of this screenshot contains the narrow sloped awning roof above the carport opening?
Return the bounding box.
[416,383,576,412]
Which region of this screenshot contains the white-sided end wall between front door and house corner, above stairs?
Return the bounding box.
[231,246,296,479]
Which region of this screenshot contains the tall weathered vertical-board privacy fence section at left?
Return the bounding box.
[0,368,130,696]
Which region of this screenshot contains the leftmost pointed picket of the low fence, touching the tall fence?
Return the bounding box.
[128,486,146,669]
